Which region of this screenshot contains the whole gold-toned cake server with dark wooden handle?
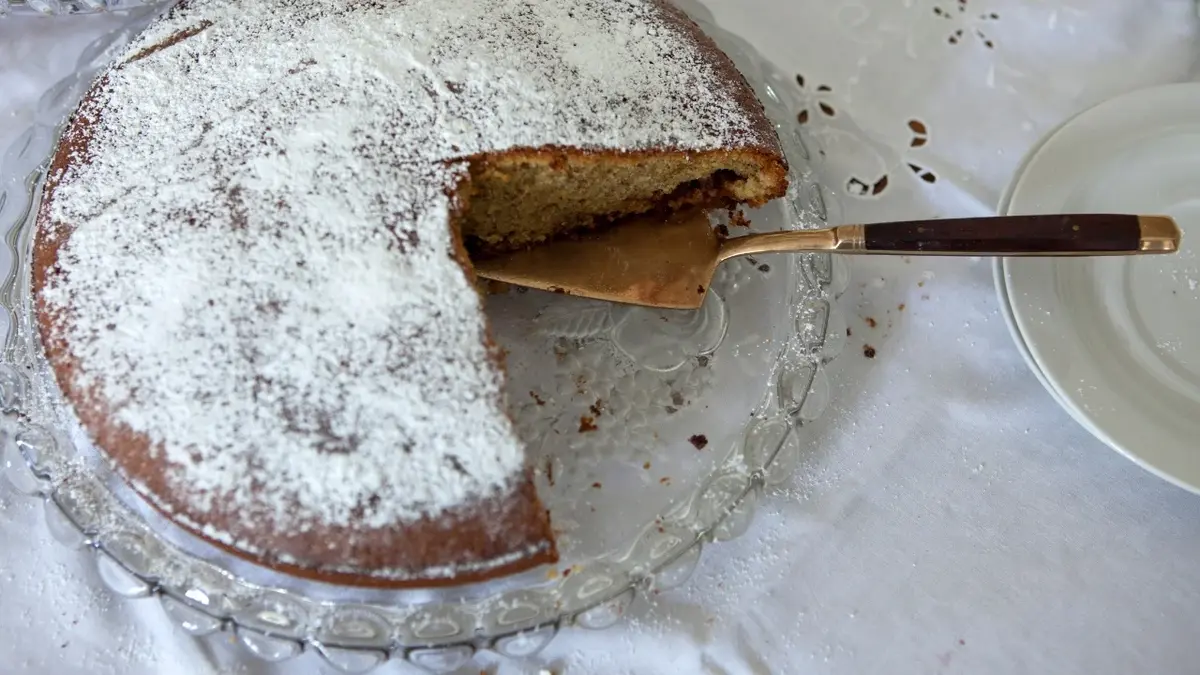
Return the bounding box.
[474,210,1182,310]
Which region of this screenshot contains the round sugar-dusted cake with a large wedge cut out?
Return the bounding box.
[32,0,787,587]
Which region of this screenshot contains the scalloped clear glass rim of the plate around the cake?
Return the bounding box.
[0,0,846,671]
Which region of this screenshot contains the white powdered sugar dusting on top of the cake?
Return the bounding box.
[43,0,763,531]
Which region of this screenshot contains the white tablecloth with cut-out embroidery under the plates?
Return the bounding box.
[0,0,1200,675]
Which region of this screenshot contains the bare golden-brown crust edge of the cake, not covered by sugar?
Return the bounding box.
[32,2,786,587]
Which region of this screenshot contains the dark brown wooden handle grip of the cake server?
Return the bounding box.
[864,214,1141,255]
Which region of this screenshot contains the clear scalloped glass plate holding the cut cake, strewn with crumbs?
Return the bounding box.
[0,0,846,673]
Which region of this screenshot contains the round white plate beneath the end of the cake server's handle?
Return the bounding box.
[1000,84,1200,492]
